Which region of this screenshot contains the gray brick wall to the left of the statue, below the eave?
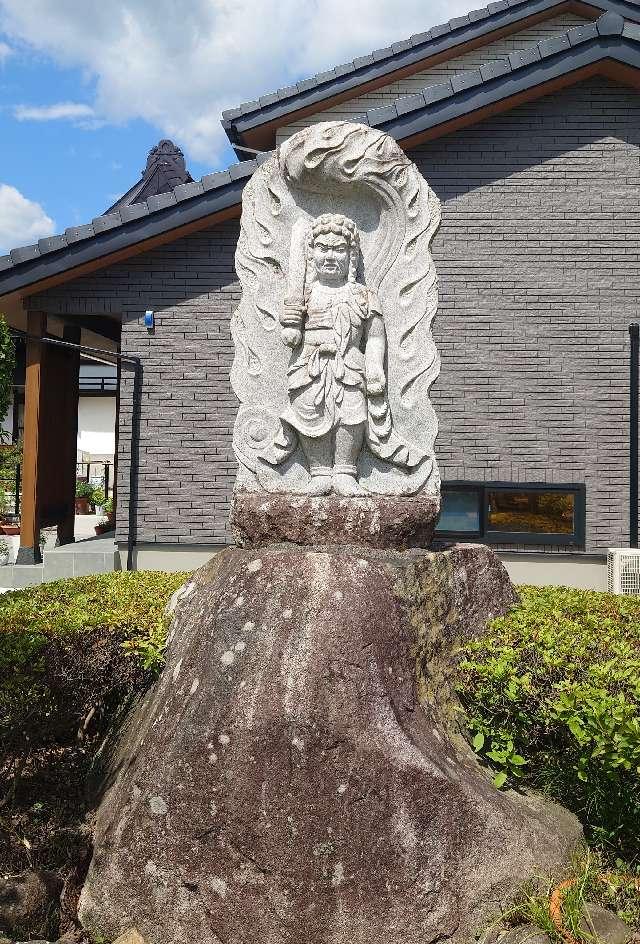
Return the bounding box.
[30,221,240,544]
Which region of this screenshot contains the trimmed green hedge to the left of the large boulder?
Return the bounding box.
[0,571,188,769]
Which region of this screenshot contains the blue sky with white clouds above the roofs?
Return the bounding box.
[0,0,470,252]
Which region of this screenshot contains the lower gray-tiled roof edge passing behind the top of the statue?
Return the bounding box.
[0,13,640,297]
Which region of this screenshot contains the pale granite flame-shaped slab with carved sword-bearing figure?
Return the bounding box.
[231,122,440,497]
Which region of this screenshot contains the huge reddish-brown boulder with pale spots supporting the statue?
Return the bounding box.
[81,545,580,944]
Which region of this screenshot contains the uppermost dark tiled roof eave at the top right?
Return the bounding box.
[222,0,640,152]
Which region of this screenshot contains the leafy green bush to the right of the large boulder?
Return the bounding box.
[458,587,640,860]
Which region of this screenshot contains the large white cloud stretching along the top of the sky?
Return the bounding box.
[0,0,473,166]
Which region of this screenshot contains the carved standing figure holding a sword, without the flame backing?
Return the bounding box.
[280,213,388,495]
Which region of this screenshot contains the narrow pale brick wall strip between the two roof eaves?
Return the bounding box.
[276,13,587,144]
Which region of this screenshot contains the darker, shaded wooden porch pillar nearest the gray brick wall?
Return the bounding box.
[58,325,81,544]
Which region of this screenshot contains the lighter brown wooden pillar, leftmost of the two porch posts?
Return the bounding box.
[16,311,47,564]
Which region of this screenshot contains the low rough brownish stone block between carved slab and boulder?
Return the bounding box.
[231,491,440,551]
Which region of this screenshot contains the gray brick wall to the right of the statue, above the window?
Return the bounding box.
[420,80,640,551]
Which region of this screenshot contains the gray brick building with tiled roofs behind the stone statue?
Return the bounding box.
[0,0,640,589]
